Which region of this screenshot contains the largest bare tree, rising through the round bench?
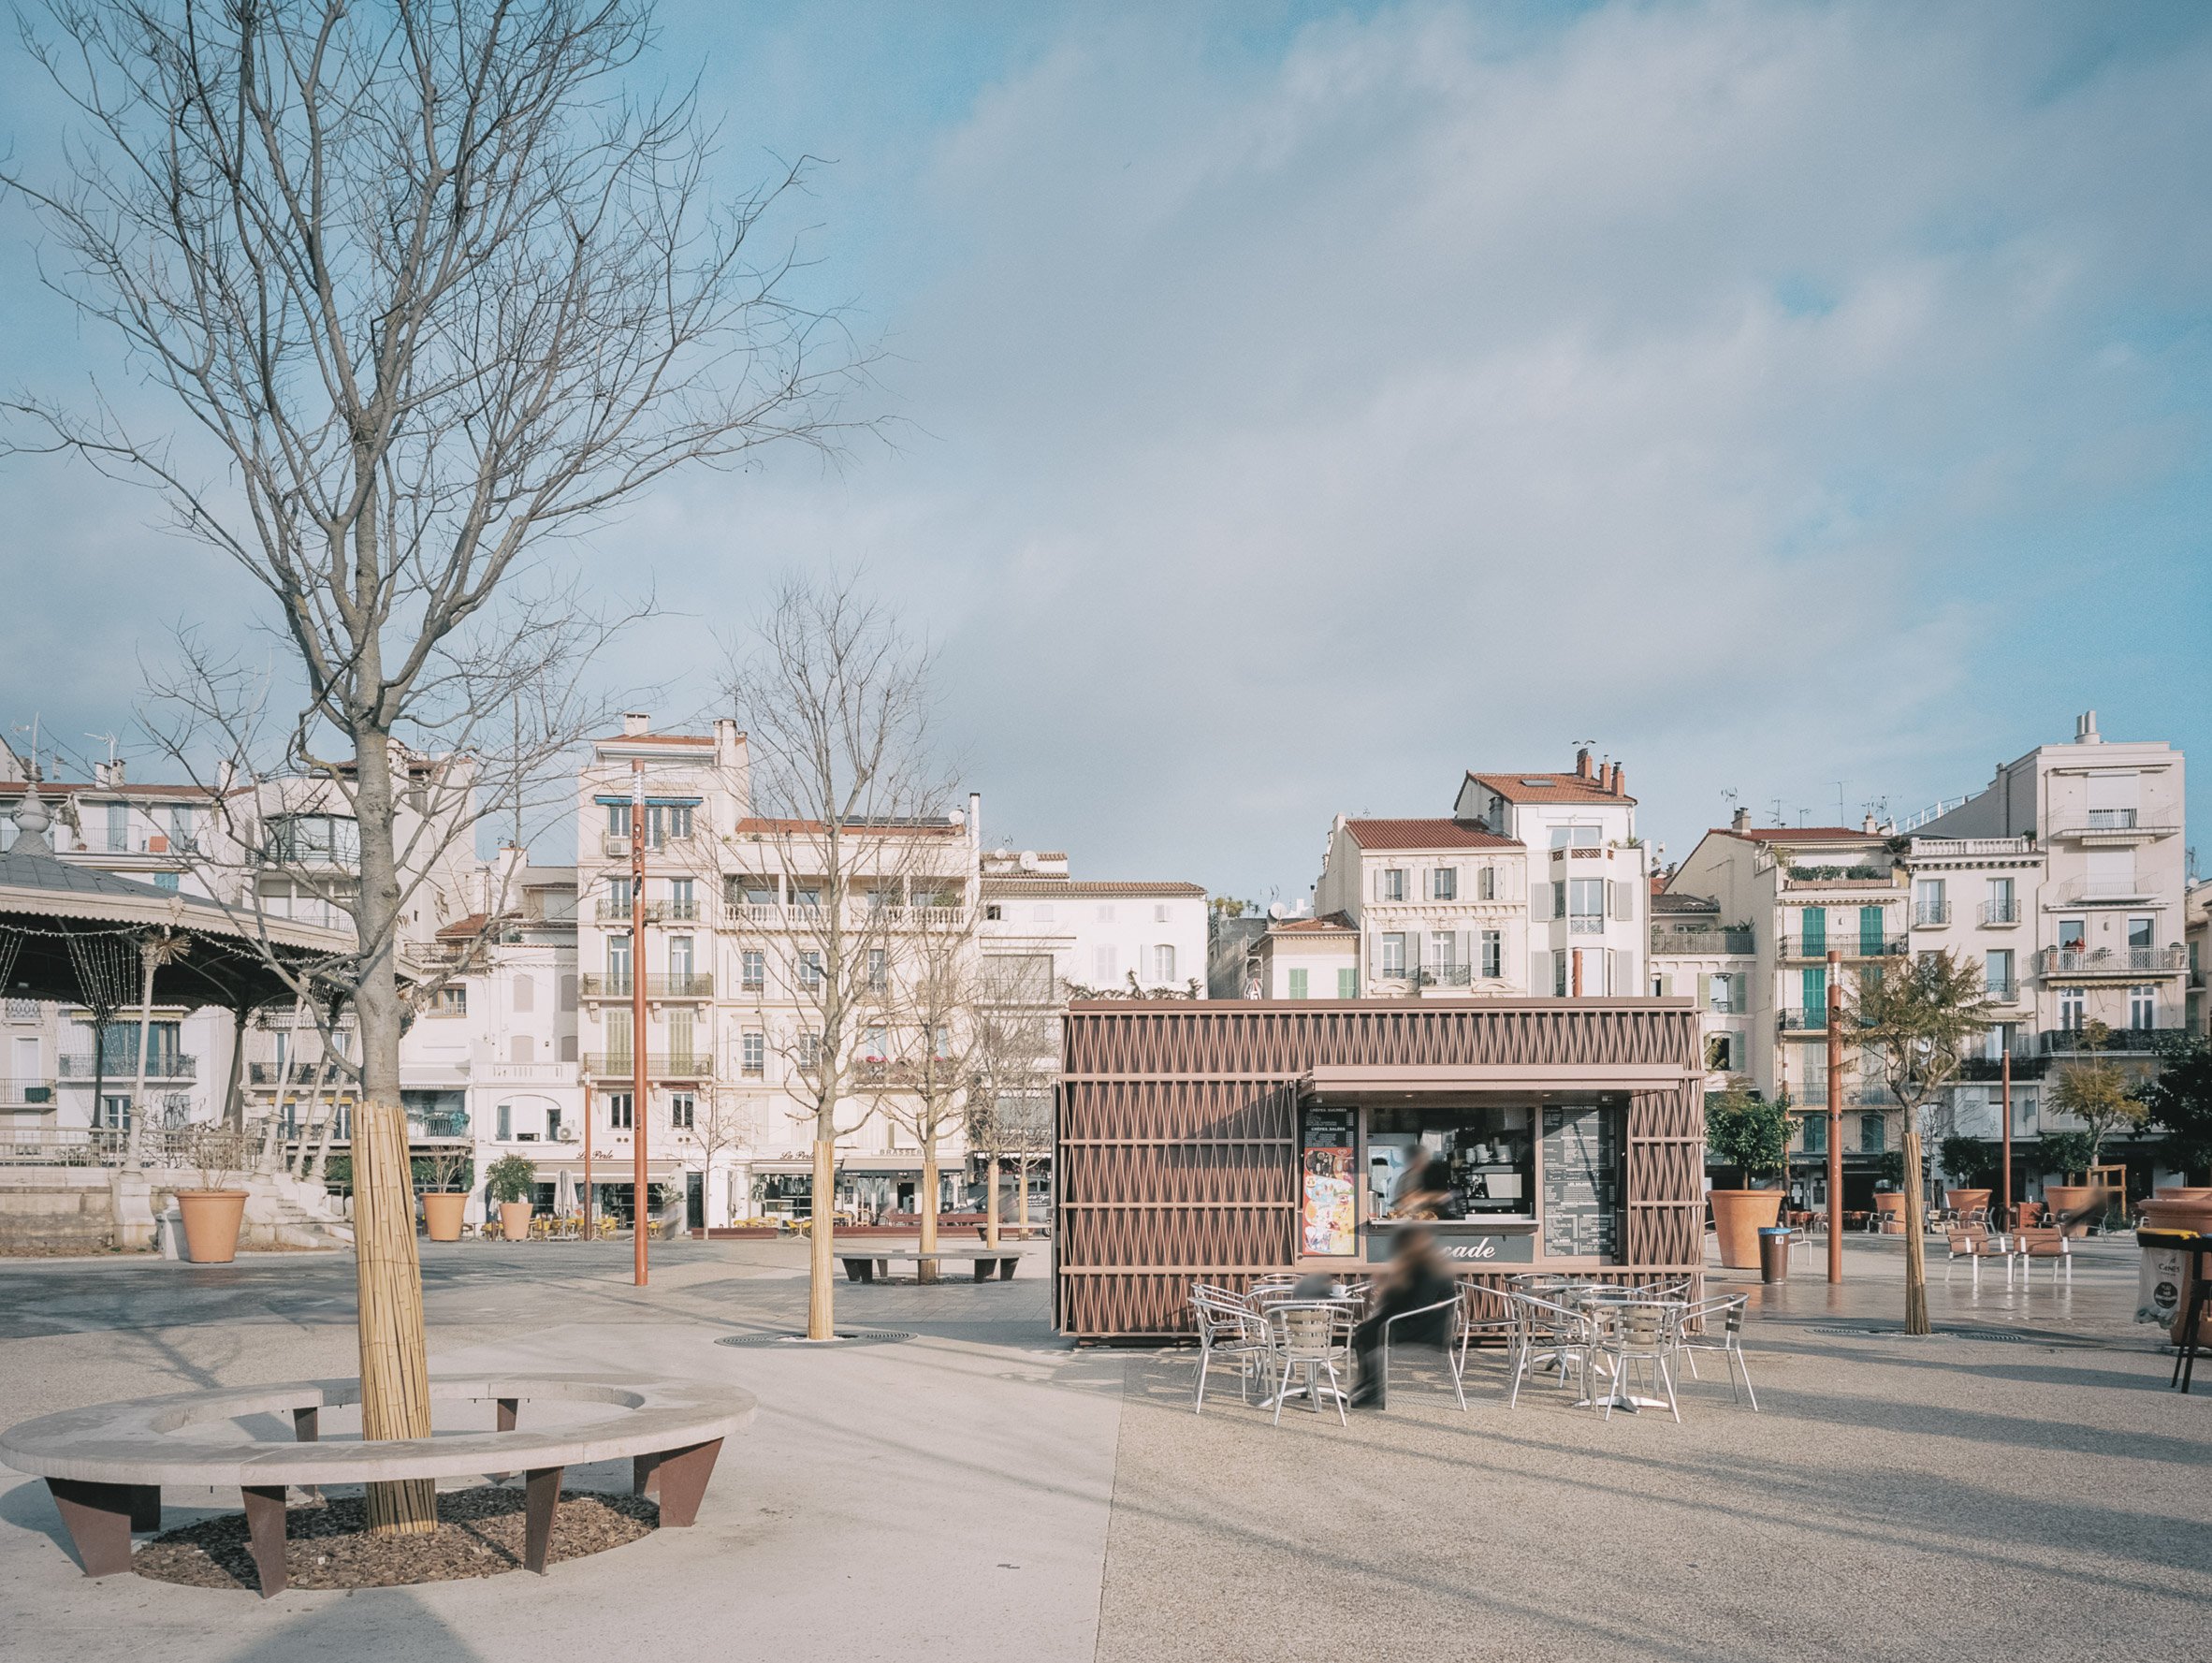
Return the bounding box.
[5,0,850,1533]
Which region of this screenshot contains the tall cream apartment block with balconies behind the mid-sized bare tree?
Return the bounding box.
[575,714,980,1227]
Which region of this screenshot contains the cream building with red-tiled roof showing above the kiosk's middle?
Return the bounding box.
[1309,814,1539,999]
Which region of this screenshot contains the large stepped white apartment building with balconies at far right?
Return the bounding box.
[1904,710,2190,1159]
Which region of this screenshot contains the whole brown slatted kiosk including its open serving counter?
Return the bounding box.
[1055,999,1703,1338]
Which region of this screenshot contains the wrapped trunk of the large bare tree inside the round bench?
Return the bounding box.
[354,734,438,1535]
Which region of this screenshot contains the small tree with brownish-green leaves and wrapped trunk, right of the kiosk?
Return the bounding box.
[1845,951,1993,1334]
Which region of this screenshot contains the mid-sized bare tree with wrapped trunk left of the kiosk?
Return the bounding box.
[728,577,965,1340]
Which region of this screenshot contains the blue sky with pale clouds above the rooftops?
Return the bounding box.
[0,2,2212,900]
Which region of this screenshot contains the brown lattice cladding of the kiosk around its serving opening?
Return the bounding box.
[1053,999,1706,1340]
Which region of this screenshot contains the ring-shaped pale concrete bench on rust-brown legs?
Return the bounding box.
[0,1373,754,1597]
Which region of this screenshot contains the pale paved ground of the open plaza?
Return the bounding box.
[0,1238,2212,1663]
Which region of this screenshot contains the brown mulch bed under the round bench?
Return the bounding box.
[130,1486,662,1590]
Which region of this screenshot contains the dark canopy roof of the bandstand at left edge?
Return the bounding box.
[0,787,357,1011]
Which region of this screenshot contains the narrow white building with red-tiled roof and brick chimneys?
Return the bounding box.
[1460,750,1652,998]
